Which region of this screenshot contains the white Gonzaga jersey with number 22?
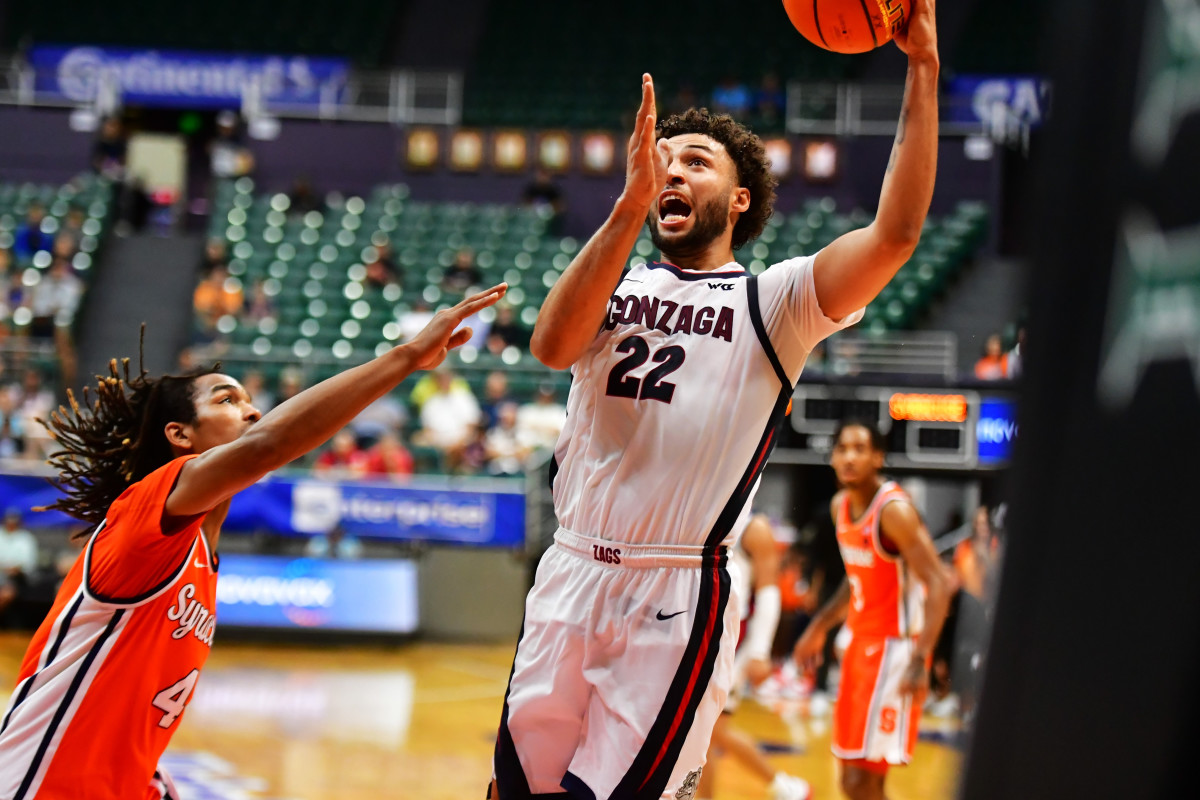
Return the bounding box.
[552,255,862,546]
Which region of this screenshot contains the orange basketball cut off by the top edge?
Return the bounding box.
[784,0,911,53]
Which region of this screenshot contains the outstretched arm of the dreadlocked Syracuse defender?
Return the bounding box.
[166,284,508,517]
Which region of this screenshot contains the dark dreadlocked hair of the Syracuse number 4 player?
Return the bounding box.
[37,338,221,535]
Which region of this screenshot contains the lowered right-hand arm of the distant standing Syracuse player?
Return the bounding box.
[880,503,954,692]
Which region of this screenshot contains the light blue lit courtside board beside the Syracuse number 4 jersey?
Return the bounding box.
[217,553,418,636]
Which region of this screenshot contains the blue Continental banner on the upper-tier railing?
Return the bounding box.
[29,44,349,108]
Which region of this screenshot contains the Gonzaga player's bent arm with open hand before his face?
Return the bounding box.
[529,74,666,369]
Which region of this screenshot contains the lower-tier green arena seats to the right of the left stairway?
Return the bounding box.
[201,179,988,407]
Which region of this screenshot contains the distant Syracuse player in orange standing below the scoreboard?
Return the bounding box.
[794,421,954,800]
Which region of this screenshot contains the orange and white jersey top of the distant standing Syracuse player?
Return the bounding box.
[836,481,924,638]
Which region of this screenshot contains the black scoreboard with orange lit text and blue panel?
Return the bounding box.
[774,384,1018,470]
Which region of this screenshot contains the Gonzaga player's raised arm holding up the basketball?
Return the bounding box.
[812,0,938,319]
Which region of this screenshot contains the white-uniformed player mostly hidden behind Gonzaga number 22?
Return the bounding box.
[696,515,812,800]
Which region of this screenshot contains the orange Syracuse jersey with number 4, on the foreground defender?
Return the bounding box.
[0,456,217,800]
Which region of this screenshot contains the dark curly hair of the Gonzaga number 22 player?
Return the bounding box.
[655,108,779,249]
